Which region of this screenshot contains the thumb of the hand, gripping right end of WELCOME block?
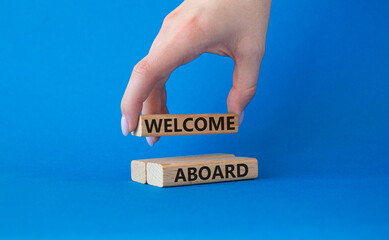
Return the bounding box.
[227,54,262,125]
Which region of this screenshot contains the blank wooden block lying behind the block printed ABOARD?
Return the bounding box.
[131,153,235,183]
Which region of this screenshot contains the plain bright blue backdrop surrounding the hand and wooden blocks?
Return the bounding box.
[0,0,389,239]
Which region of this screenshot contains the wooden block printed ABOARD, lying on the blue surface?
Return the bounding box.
[147,157,258,187]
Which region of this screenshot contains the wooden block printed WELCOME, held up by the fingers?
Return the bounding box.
[131,113,239,137]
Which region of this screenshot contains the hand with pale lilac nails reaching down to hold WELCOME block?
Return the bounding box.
[121,0,271,146]
